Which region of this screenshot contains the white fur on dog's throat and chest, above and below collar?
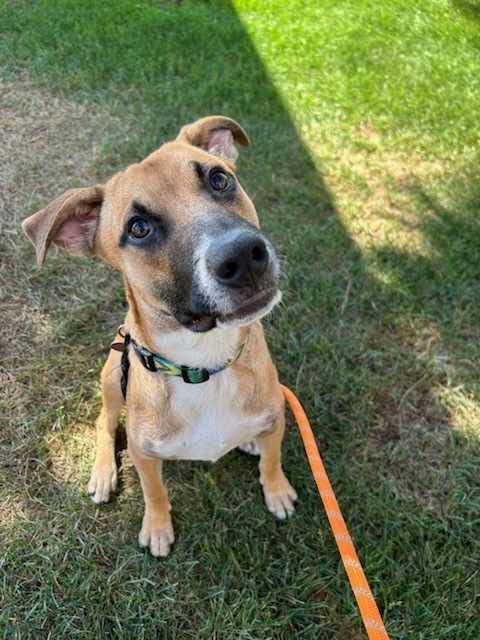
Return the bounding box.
[127,327,272,461]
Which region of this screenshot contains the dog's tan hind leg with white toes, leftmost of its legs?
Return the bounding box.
[88,350,123,504]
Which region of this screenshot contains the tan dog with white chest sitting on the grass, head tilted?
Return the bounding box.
[23,116,297,556]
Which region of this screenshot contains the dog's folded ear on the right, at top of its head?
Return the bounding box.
[177,116,250,163]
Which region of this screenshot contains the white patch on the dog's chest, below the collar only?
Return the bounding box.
[144,371,268,461]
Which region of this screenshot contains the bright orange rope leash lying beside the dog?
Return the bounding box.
[280,384,389,640]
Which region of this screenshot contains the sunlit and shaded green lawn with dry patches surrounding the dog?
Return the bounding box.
[0,0,480,640]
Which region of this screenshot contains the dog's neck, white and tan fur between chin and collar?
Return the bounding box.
[122,296,248,369]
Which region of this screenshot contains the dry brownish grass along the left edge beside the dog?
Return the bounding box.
[0,75,127,508]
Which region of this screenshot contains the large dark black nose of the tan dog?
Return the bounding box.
[207,231,270,288]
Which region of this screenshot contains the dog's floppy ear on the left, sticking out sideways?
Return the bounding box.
[22,185,103,267]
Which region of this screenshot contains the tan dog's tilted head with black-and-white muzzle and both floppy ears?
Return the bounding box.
[23,116,280,331]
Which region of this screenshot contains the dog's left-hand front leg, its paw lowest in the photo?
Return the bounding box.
[128,441,175,557]
